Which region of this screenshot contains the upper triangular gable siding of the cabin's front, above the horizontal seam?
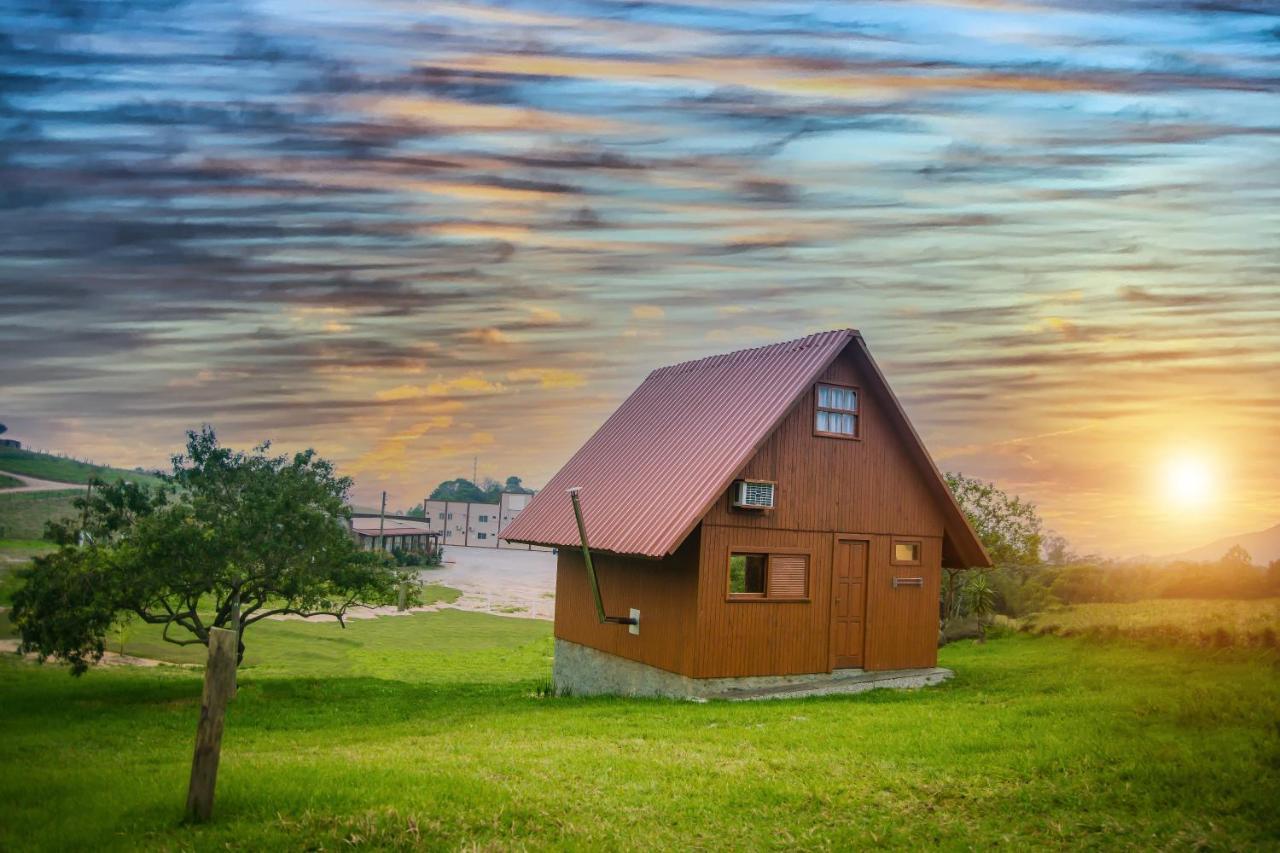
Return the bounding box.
[703,353,943,537]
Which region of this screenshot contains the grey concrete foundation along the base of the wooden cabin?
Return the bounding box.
[553,638,954,699]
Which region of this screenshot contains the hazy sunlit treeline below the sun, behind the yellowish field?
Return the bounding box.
[988,546,1280,616]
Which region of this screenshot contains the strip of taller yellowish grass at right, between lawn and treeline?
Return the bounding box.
[1020,598,1280,648]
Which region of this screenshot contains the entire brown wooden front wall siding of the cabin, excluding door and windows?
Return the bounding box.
[692,343,943,678]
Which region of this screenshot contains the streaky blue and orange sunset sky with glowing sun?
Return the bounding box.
[0,0,1280,556]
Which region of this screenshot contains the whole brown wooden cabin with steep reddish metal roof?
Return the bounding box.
[503,329,989,693]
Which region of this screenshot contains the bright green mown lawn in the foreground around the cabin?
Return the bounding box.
[0,611,1280,849]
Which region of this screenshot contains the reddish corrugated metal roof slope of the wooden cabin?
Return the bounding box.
[502,329,858,557]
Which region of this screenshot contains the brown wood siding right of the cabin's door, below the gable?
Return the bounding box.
[863,537,942,670]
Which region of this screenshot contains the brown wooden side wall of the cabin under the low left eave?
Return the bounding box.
[556,529,699,675]
